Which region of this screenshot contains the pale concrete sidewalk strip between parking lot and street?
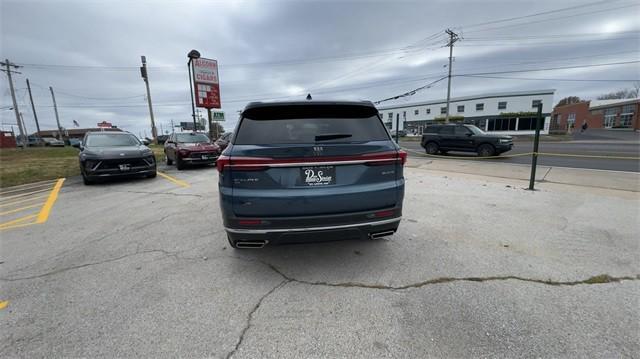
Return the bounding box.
[407,157,640,192]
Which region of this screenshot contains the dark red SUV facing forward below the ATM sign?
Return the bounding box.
[164,132,221,170]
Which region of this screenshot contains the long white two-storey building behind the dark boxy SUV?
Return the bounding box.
[378,90,555,135]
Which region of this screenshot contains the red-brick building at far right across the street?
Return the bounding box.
[551,98,640,132]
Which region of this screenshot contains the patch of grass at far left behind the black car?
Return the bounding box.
[0,147,80,188]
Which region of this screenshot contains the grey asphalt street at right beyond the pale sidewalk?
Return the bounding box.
[400,136,640,172]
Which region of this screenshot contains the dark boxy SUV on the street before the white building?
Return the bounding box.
[421,124,513,157]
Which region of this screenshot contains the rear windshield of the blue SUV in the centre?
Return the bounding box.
[234,116,389,145]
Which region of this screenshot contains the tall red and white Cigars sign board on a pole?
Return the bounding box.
[192,58,221,108]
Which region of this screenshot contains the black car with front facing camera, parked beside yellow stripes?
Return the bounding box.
[75,132,157,185]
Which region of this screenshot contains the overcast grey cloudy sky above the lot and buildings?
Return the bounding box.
[0,0,640,136]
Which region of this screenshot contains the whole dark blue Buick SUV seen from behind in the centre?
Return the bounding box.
[217,101,407,248]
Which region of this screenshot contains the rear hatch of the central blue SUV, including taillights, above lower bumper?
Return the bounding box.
[218,103,406,218]
